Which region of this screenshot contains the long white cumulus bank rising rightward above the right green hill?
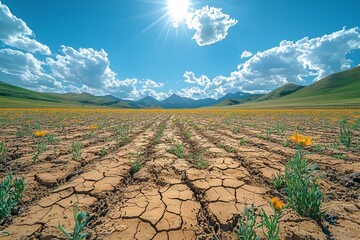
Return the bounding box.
[183,27,360,98]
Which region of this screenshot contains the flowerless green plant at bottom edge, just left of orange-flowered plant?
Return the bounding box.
[236,204,259,240]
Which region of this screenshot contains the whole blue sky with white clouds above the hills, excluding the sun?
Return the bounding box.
[0,0,360,99]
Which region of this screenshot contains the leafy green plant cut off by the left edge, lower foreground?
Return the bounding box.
[0,173,25,220]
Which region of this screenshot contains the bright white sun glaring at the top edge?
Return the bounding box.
[167,0,190,27]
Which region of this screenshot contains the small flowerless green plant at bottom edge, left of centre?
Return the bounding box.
[59,195,91,240]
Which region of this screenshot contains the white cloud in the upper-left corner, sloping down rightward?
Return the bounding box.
[0,1,51,55]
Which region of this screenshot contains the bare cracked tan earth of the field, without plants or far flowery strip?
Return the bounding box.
[0,109,360,240]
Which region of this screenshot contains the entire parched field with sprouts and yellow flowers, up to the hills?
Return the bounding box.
[0,109,360,240]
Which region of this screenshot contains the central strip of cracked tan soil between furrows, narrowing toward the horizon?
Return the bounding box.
[96,118,201,240]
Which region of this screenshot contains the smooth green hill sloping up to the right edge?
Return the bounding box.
[229,66,360,108]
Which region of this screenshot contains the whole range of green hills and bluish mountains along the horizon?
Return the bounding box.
[0,67,360,109]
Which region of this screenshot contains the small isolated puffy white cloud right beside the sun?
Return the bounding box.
[186,6,237,46]
